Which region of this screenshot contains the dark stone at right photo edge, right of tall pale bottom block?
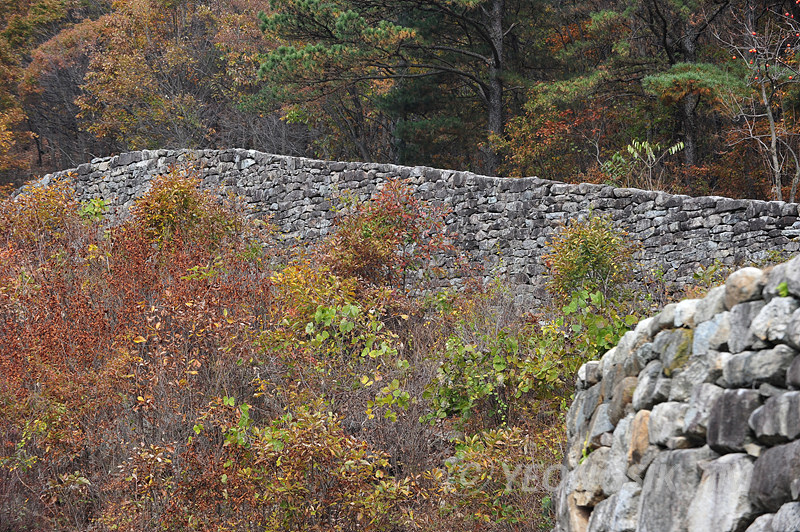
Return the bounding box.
[750,440,800,512]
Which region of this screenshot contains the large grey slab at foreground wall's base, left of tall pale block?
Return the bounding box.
[637,447,718,532]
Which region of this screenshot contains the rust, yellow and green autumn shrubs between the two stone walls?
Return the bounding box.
[0,173,648,531]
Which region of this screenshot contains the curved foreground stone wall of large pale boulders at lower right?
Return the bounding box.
[556,257,800,532]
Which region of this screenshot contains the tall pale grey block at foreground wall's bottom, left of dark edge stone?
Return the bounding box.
[687,454,757,532]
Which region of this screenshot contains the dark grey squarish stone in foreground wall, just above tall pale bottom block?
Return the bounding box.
[707,390,761,452]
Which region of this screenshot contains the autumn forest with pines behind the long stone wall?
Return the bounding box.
[0,0,800,200]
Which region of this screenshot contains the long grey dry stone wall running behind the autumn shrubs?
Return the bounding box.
[43,149,800,302]
